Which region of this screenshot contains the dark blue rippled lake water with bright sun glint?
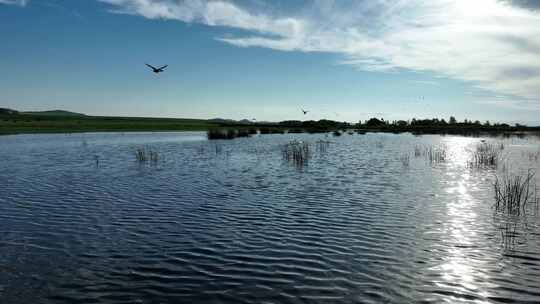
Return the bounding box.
[0,133,540,303]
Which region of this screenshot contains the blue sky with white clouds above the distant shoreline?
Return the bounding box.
[0,0,540,125]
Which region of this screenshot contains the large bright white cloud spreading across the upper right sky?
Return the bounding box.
[98,0,540,103]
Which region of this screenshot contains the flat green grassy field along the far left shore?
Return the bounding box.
[0,113,219,134]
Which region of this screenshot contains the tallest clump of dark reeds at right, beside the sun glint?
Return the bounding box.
[493,170,538,215]
